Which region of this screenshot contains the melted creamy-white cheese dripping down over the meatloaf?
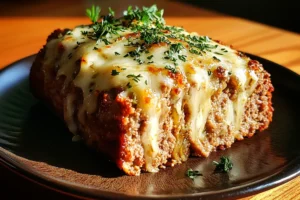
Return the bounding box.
[45,26,258,172]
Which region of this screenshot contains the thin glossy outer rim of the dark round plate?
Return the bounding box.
[0,53,300,199]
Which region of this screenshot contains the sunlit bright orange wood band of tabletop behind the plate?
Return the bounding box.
[0,16,300,74]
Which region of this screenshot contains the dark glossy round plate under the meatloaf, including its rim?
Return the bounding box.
[0,55,300,199]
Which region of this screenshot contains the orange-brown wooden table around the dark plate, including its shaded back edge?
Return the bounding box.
[0,1,300,200]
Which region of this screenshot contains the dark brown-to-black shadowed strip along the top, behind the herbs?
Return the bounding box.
[0,0,300,33]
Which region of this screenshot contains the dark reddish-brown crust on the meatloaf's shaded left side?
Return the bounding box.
[30,30,144,175]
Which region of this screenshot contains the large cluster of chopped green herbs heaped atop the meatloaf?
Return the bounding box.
[83,5,227,72]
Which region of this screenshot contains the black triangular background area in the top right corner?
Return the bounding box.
[181,0,300,33]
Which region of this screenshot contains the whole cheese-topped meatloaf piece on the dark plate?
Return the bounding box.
[30,7,273,175]
